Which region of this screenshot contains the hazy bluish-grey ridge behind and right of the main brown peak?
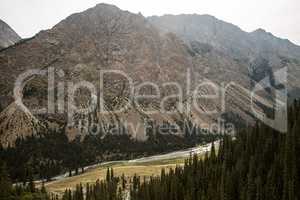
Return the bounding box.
[148,14,300,59]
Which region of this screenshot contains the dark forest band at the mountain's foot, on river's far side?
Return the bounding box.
[0,122,218,183]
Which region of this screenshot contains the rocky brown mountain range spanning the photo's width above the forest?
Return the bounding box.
[0,4,300,143]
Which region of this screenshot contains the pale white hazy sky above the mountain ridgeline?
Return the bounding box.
[0,0,300,45]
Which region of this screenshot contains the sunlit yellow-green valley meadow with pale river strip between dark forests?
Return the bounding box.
[37,141,219,195]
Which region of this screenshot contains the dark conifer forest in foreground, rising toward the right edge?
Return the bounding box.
[63,101,300,200]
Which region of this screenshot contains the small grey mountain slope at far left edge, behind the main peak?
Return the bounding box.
[0,20,21,49]
